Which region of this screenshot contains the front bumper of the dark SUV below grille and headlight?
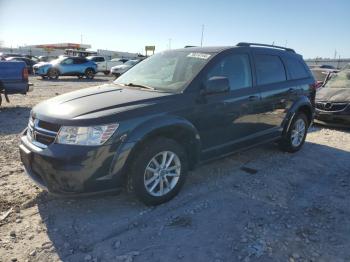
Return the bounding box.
[19,132,130,195]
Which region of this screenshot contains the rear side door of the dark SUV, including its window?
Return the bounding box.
[254,50,296,135]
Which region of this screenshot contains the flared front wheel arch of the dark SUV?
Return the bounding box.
[110,115,200,179]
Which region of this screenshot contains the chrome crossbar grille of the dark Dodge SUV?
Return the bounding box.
[27,117,60,148]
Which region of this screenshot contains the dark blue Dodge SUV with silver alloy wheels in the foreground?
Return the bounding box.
[20,43,315,205]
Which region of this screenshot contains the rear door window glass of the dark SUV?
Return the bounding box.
[255,55,286,85]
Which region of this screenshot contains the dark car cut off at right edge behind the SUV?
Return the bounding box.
[315,69,350,127]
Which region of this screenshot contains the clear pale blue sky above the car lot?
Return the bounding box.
[0,0,350,58]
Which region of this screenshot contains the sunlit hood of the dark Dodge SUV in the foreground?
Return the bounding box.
[32,84,172,123]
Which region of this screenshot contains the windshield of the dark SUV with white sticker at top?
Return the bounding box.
[114,51,212,92]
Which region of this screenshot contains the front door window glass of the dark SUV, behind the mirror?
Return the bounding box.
[207,54,252,90]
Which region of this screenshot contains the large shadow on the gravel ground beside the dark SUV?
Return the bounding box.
[37,142,350,261]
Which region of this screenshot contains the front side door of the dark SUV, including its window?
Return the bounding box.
[195,50,261,158]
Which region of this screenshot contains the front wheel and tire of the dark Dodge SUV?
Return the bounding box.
[129,138,188,205]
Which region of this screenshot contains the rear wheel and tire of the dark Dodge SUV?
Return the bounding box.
[279,112,309,153]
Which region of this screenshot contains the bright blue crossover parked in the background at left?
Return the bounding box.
[33,56,97,79]
